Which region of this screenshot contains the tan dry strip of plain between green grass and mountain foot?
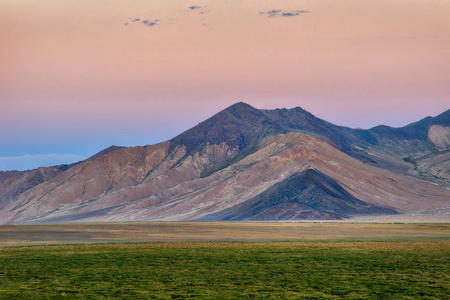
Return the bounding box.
[0,222,450,246]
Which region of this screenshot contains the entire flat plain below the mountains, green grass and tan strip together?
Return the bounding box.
[0,222,450,299]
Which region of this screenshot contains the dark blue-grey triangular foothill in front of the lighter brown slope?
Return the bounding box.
[199,169,397,221]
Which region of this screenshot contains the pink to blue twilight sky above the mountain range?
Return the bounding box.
[0,0,450,170]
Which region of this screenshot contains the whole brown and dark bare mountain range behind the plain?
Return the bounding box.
[0,102,450,224]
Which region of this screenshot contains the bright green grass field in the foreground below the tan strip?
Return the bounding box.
[0,239,450,299]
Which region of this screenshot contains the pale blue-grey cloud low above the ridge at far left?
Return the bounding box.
[0,153,87,171]
